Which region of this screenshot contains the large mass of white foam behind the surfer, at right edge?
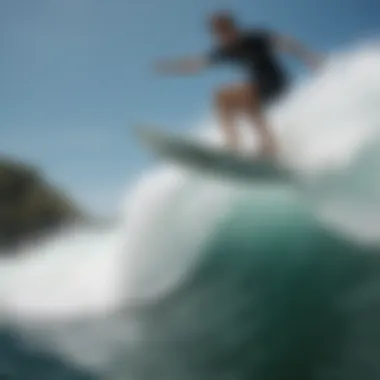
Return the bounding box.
[275,43,380,244]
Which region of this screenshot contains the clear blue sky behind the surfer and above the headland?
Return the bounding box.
[0,0,380,214]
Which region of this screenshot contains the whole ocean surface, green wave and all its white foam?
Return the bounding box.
[0,43,380,380]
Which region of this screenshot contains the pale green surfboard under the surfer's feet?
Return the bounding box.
[136,127,292,182]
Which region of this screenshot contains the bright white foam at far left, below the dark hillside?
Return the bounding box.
[0,226,127,320]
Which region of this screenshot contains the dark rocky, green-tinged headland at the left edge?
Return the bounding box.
[0,157,86,254]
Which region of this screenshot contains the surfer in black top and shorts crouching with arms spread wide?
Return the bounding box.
[157,12,320,155]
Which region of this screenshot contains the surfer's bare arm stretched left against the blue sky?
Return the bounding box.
[155,57,208,75]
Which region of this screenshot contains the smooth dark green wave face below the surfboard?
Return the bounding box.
[120,187,380,380]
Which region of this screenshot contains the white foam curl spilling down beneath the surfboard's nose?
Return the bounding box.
[121,167,232,299]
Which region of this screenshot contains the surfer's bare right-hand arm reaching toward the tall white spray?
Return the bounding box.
[275,35,323,69]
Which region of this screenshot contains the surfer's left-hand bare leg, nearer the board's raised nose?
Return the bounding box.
[215,86,240,150]
